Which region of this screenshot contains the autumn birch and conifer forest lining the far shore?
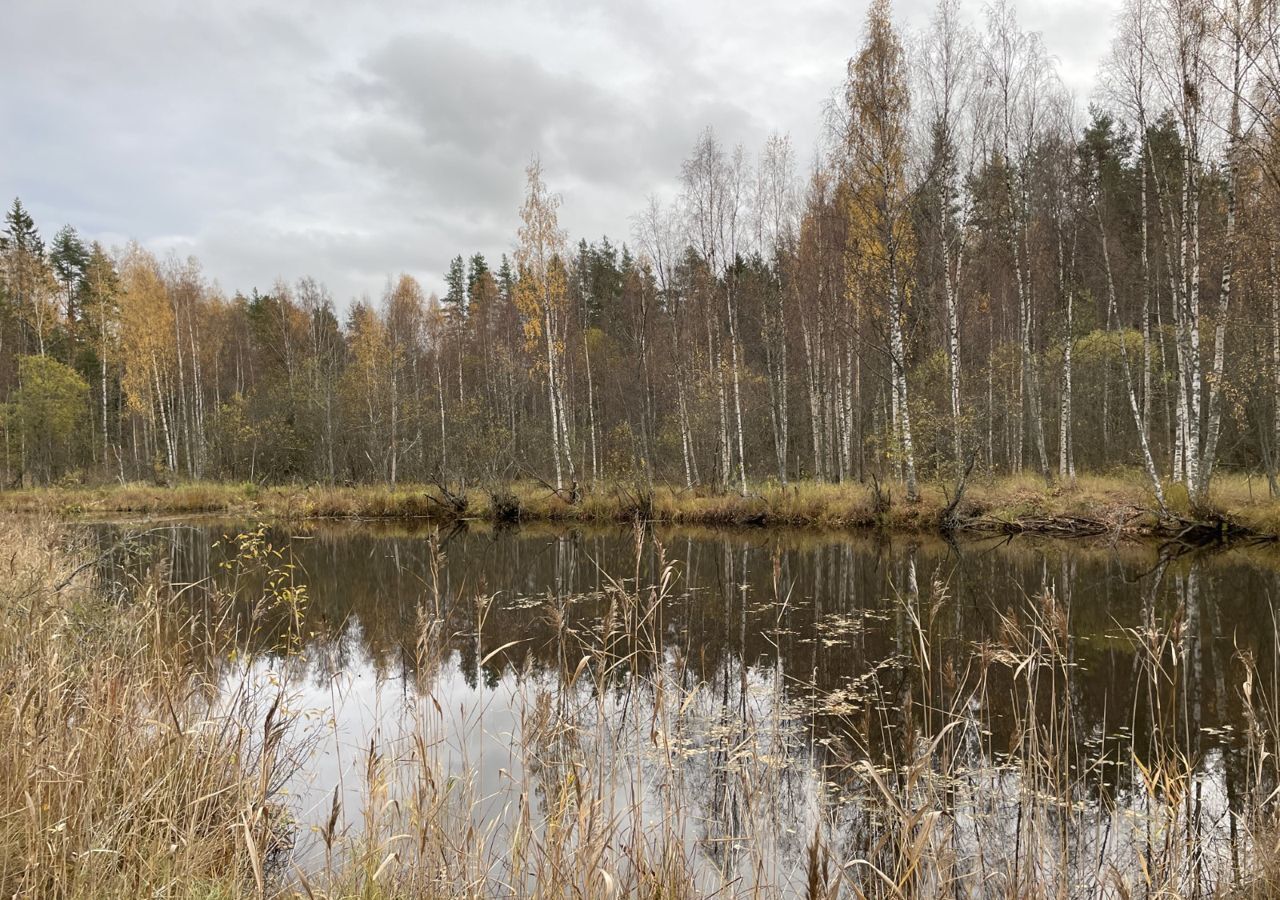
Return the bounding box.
[0,0,1280,503]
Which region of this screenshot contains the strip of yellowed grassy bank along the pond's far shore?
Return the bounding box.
[0,472,1280,542]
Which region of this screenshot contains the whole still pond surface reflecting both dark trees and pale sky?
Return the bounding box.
[99,521,1280,896]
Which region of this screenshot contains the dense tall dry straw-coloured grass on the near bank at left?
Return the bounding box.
[0,521,296,899]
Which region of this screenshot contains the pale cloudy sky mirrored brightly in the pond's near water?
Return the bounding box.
[228,621,1243,897]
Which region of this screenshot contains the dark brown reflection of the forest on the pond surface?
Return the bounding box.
[100,526,1275,885]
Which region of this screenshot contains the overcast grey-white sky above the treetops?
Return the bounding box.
[0,0,1119,305]
